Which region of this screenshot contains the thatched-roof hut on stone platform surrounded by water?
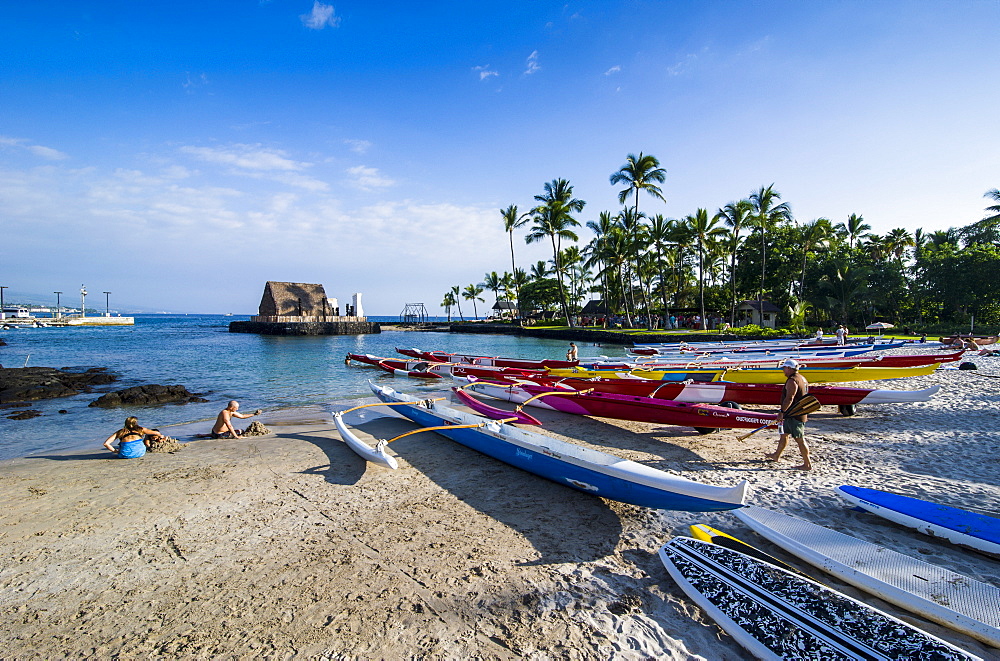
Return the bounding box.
[229,280,382,335]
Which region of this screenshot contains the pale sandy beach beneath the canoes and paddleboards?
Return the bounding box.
[0,357,1000,659]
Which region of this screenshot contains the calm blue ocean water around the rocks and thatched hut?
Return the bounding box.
[0,315,624,459]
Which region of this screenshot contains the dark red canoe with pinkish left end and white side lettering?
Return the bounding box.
[458,381,778,433]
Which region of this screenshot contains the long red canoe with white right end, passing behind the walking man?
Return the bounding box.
[464,376,941,413]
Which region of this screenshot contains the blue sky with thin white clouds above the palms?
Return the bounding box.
[0,0,1000,315]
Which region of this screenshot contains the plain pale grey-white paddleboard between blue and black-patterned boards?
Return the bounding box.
[733,505,1000,647]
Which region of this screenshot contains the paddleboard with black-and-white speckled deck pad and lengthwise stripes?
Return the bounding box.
[659,537,979,661]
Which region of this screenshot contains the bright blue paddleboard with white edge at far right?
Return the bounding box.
[837,485,1000,555]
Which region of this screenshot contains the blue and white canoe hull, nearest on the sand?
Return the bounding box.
[341,382,747,512]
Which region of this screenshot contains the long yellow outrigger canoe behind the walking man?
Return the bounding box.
[549,363,940,383]
